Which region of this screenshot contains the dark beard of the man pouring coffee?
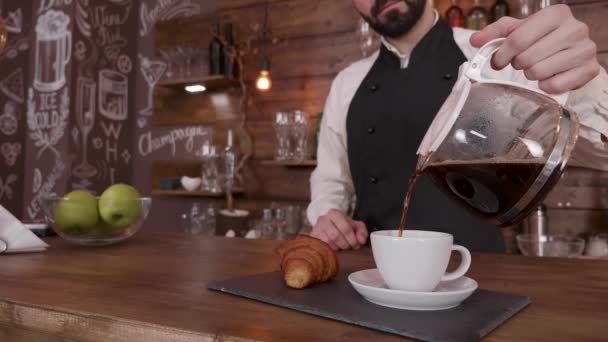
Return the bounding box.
[361,0,426,38]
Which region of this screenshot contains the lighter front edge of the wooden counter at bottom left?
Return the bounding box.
[0,298,253,342]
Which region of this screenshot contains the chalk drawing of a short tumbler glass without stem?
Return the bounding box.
[98,69,129,121]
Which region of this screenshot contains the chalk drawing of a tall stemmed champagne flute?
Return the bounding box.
[72,78,97,178]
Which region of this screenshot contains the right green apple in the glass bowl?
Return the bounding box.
[98,184,141,229]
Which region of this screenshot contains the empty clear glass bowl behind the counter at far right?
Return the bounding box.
[516,234,585,257]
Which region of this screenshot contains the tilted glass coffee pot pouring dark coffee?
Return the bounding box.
[417,38,579,226]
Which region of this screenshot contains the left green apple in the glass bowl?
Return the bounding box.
[53,190,99,234]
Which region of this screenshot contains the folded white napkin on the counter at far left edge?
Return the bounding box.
[0,205,48,253]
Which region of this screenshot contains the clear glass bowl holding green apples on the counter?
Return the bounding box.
[42,196,152,246]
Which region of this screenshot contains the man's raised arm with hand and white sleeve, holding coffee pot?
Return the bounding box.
[470,5,608,170]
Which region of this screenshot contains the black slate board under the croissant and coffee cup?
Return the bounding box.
[208,270,530,341]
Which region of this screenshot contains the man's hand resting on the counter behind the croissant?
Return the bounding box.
[310,209,368,251]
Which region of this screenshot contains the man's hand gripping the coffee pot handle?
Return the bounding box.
[471,5,600,94]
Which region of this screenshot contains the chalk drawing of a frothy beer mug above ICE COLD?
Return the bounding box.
[34,10,72,92]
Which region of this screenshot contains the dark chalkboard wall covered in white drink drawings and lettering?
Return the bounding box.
[0,0,215,220]
